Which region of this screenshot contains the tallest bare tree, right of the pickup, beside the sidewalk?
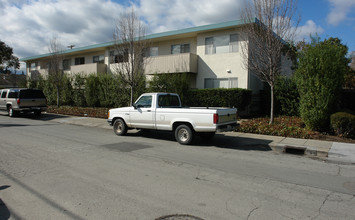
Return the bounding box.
[241,0,300,124]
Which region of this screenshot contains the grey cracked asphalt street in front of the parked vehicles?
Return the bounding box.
[0,115,355,220]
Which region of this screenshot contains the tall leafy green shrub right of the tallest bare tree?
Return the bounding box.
[296,38,348,131]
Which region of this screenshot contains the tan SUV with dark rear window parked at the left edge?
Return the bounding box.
[0,89,47,117]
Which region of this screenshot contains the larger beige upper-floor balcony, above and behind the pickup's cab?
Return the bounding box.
[145,53,198,74]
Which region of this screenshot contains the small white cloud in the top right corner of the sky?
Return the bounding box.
[327,0,355,26]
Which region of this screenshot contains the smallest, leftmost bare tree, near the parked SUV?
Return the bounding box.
[48,37,64,107]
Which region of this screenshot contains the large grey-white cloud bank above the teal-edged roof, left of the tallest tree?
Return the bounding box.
[0,0,249,62]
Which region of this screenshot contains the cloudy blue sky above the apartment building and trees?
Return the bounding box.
[0,0,355,73]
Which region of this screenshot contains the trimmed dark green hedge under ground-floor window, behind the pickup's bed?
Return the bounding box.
[186,88,252,110]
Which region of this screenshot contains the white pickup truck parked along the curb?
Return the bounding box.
[107,93,237,144]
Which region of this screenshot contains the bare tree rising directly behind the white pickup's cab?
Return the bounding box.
[111,10,150,105]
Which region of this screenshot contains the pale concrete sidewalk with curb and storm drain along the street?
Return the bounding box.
[42,114,355,164]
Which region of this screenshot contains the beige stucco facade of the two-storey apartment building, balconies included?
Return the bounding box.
[24,28,270,93]
